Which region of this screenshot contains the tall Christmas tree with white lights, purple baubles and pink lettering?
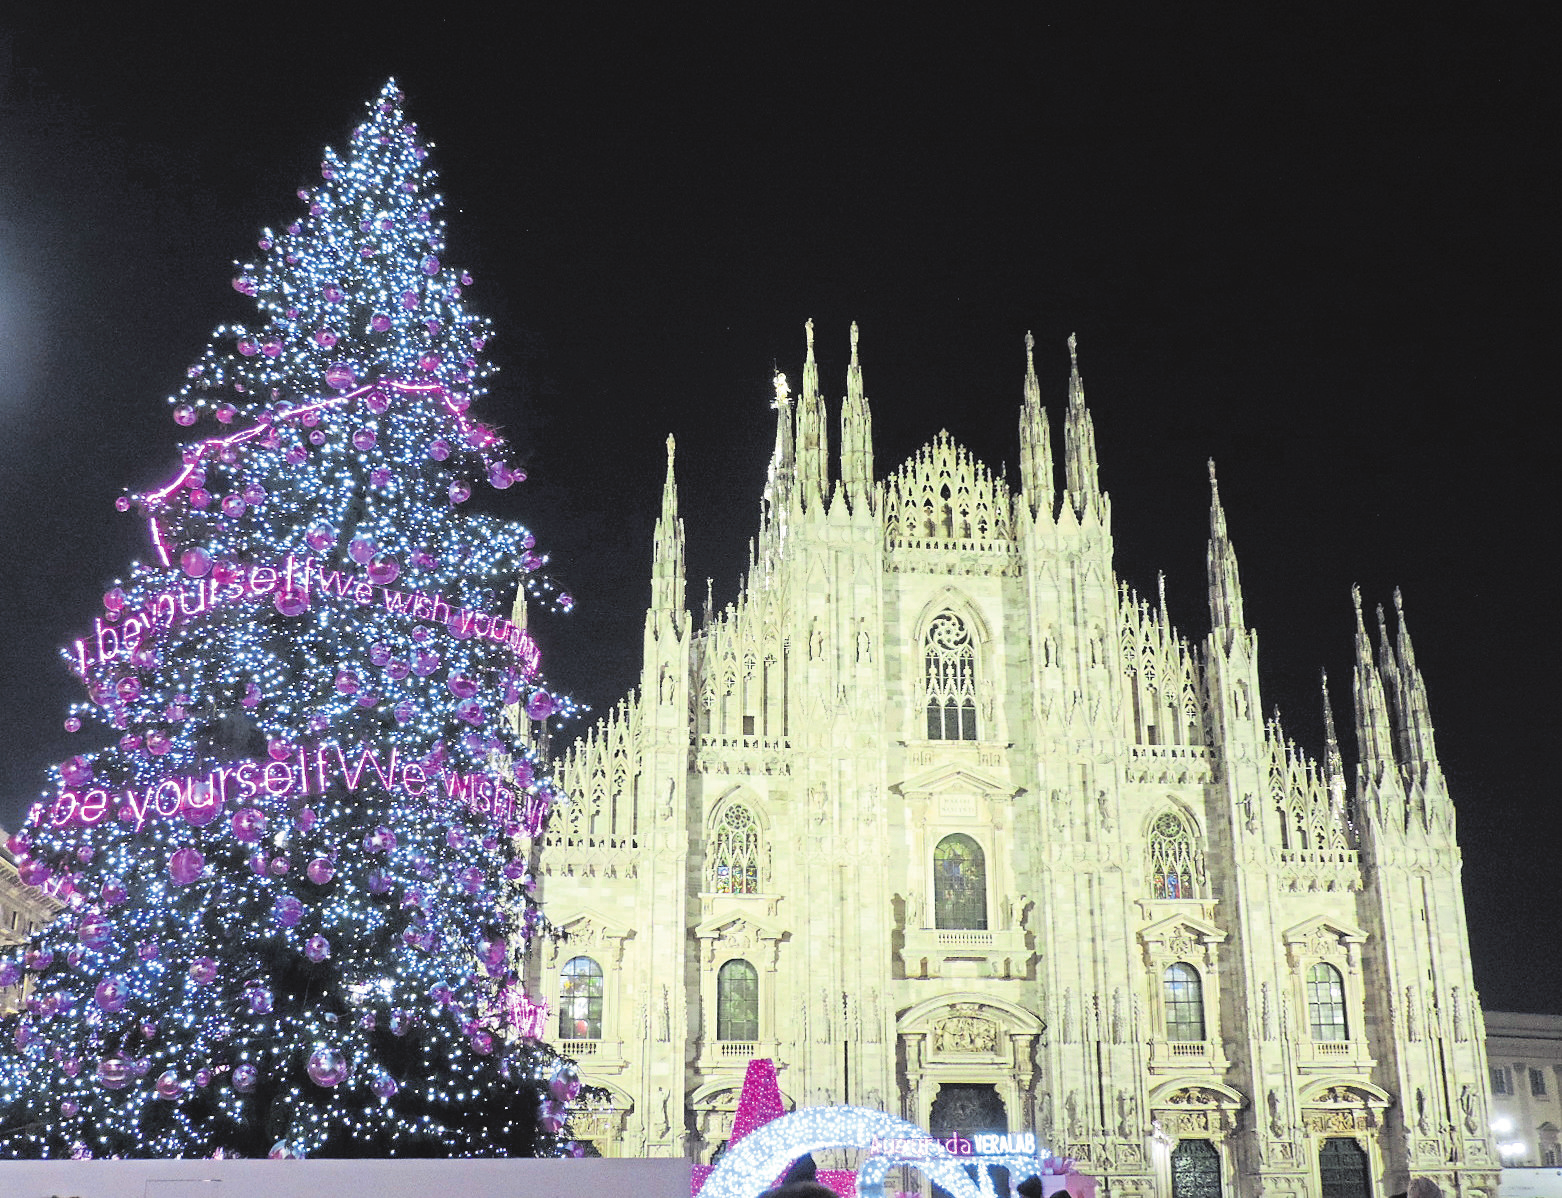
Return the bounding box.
[0,83,578,1156]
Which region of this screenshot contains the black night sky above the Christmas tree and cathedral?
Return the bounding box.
[0,11,1562,1011]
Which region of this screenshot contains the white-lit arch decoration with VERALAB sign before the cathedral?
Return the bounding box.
[700,1106,1045,1198]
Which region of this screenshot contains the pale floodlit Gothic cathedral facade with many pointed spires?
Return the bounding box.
[537,326,1496,1198]
